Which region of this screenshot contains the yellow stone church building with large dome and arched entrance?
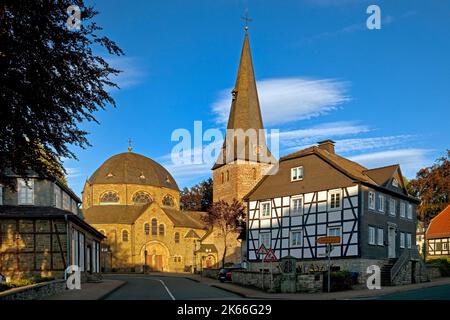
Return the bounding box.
[83,149,240,272]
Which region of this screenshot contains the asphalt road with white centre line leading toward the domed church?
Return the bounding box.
[105,275,242,300]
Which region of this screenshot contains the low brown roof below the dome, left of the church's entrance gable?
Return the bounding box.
[83,204,151,224]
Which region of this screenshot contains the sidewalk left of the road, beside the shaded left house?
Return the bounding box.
[43,280,125,300]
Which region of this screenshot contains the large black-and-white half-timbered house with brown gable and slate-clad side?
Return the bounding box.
[245,140,428,282]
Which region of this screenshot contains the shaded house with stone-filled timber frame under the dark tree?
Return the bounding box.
[0,174,104,281]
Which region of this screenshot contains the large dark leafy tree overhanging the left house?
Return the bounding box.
[0,0,123,186]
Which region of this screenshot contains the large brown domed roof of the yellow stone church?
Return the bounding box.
[88,152,179,190]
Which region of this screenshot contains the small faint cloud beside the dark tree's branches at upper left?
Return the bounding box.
[105,57,145,90]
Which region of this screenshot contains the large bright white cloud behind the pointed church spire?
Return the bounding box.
[212,77,350,126]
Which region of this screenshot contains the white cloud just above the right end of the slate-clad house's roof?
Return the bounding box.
[349,149,432,178]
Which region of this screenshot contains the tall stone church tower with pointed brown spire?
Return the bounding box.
[212,27,275,203]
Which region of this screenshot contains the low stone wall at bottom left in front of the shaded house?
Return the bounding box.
[0,280,66,300]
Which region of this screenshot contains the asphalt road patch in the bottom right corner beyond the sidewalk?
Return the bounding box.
[374,285,450,300]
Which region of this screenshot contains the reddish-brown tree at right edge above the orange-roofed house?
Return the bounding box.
[408,150,450,223]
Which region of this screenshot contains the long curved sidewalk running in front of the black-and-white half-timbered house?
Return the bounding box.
[165,274,450,300]
